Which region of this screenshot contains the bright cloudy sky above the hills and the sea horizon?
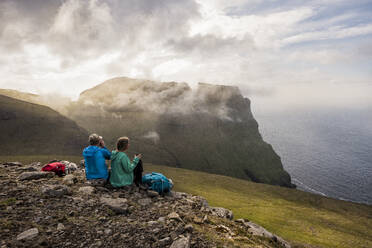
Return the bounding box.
[0,0,372,106]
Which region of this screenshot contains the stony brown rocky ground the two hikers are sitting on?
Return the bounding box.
[0,162,290,248]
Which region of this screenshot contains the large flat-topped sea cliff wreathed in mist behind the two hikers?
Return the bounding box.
[69,78,292,187]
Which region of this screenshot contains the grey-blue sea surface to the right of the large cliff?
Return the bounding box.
[252,103,372,204]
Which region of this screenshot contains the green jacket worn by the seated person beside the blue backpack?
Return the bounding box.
[110,151,139,187]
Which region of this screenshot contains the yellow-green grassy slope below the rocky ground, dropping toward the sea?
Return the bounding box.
[0,156,372,247]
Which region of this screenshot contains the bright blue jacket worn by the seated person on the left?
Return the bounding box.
[83,146,111,180]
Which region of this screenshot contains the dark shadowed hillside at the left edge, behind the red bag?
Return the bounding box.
[0,95,88,155]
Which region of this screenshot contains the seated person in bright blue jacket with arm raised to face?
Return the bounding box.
[83,133,111,184]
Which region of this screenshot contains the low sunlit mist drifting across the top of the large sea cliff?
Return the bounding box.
[76,77,241,121]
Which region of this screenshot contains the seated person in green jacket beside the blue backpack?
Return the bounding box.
[110,137,142,188]
